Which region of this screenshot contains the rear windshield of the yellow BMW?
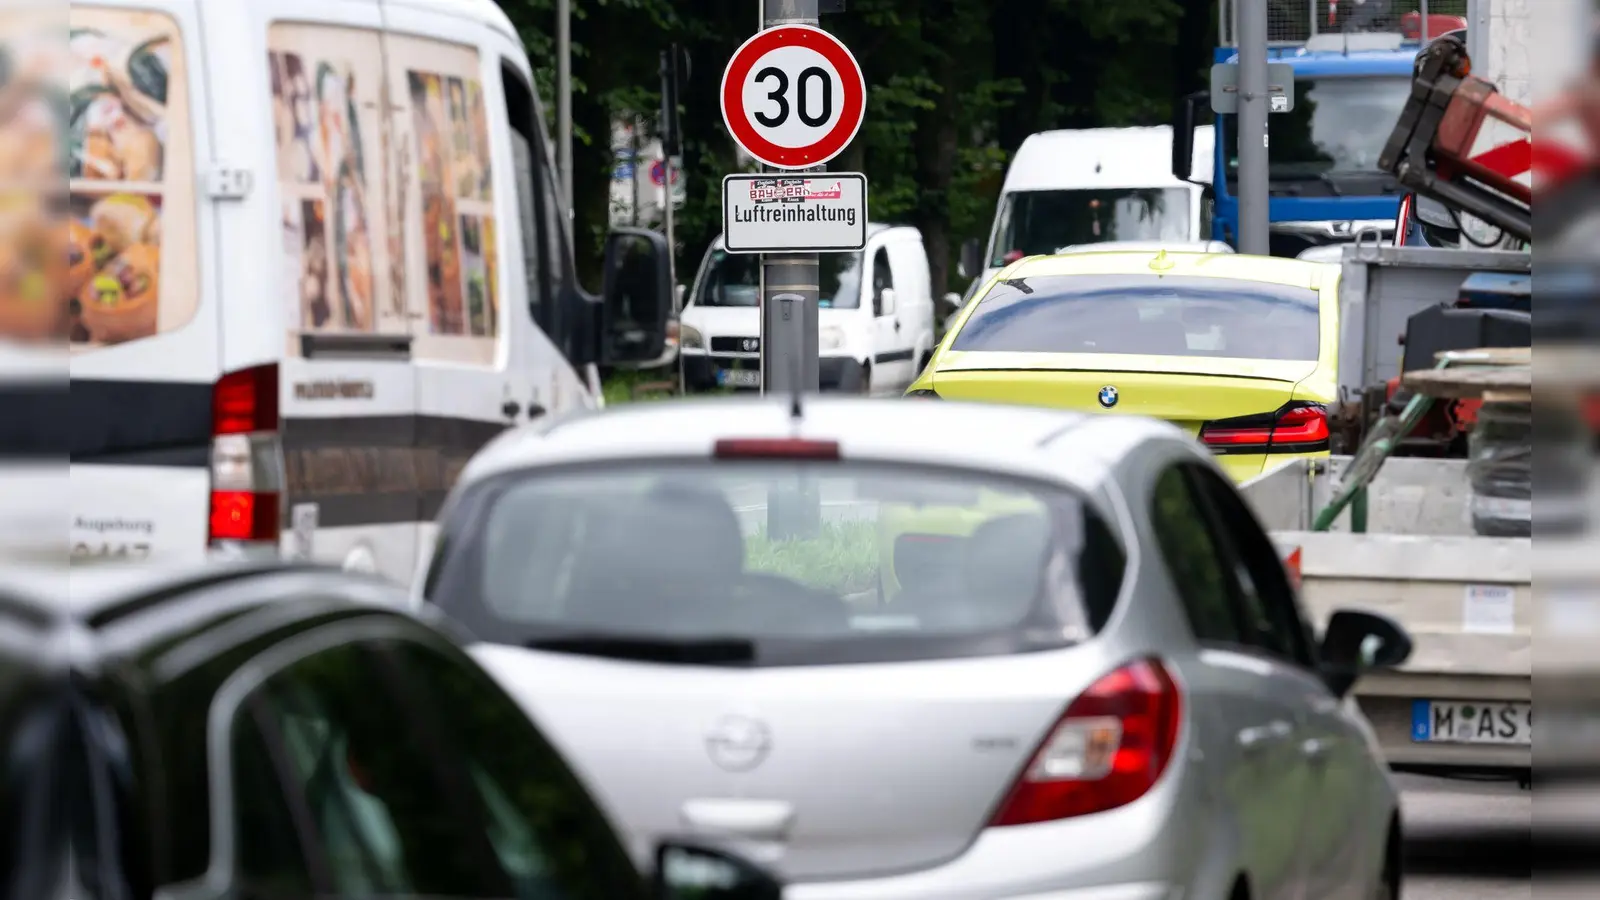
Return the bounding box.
[950,274,1322,360]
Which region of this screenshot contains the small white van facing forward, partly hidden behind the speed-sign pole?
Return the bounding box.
[678,224,934,394]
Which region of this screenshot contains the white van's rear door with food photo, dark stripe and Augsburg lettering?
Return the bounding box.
[59,0,222,559]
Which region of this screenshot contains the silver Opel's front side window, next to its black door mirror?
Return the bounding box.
[1189,466,1315,668]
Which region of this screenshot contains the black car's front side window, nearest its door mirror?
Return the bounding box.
[384,642,643,900]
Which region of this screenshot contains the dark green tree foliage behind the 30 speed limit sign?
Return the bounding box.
[499,0,1216,290]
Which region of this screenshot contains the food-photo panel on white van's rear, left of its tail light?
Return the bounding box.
[62,6,197,349]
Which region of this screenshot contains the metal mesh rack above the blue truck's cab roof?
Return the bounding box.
[1218,0,1469,46]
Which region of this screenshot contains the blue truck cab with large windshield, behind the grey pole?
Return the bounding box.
[1173,22,1452,258]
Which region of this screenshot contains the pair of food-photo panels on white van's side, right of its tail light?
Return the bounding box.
[269,22,498,353]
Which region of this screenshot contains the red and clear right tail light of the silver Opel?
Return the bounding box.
[989,658,1182,828]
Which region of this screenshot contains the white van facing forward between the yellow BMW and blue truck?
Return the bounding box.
[960,125,1214,296]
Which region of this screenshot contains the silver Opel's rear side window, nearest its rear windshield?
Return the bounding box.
[1150,466,1243,645]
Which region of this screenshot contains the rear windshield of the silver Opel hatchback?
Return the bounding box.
[424,460,1126,666]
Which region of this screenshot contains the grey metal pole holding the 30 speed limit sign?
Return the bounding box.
[757,0,822,394]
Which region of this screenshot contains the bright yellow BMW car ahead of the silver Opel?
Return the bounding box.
[907,251,1339,480]
